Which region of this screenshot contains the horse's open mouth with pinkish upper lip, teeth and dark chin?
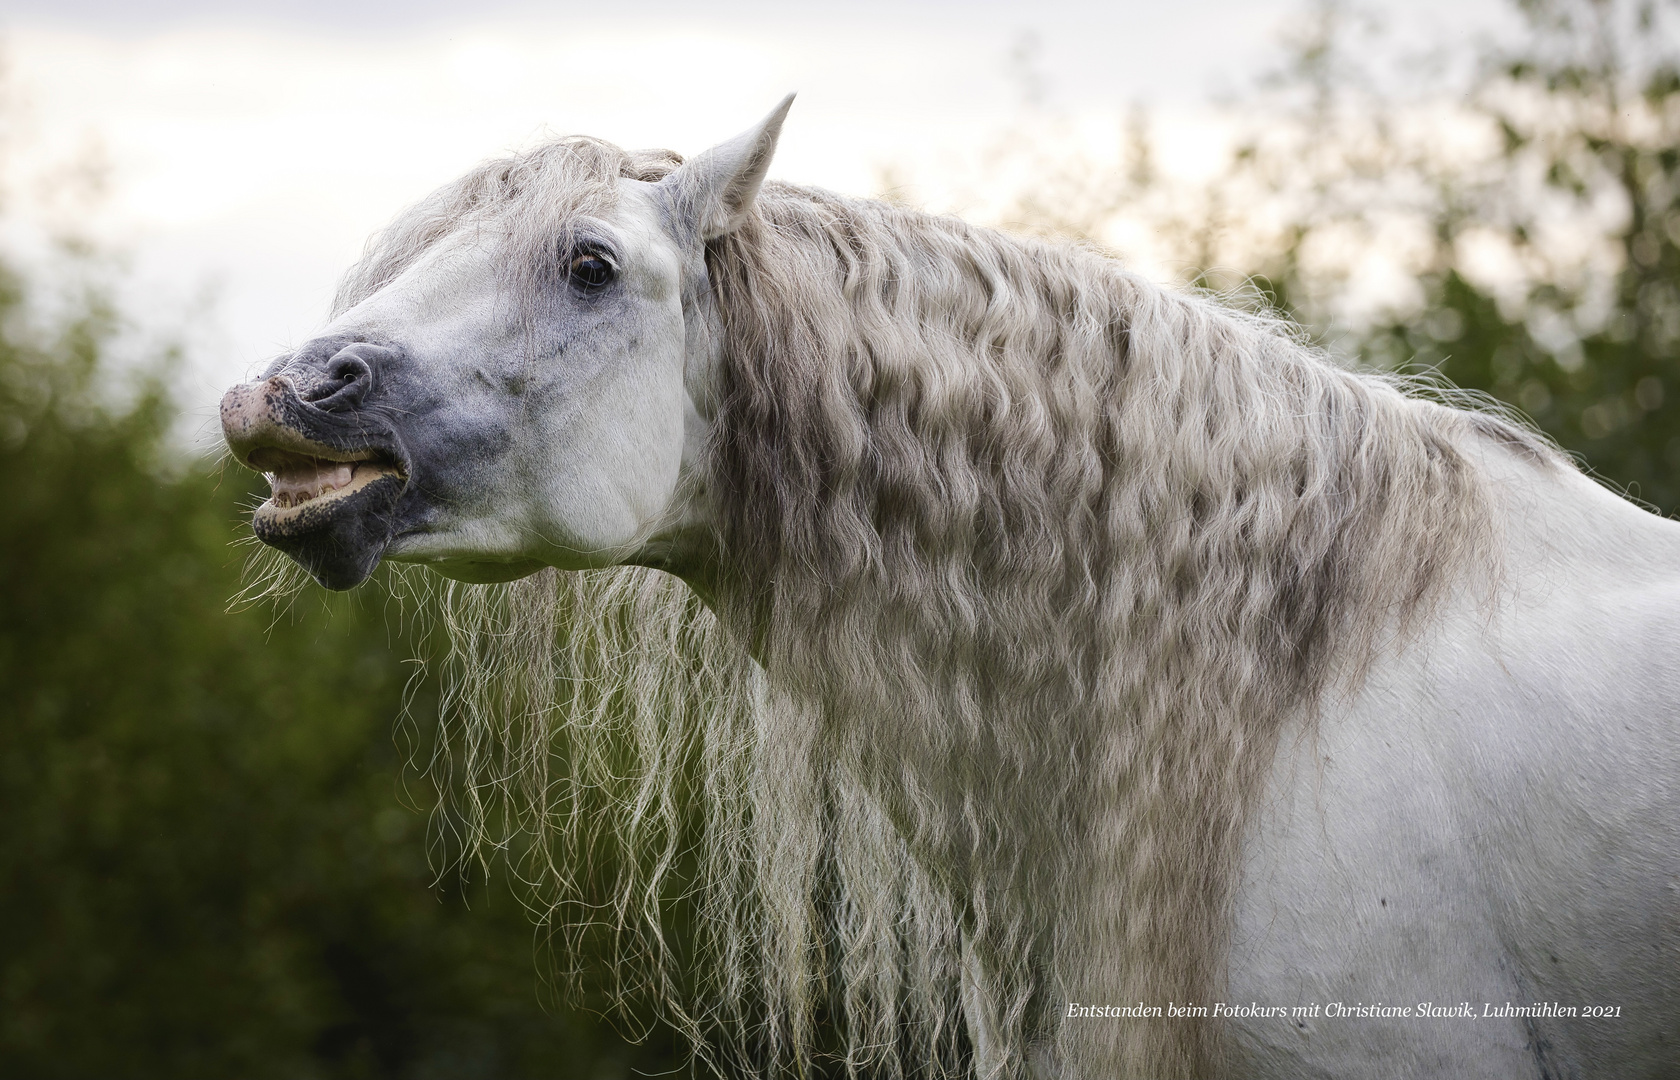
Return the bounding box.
[222,376,408,590]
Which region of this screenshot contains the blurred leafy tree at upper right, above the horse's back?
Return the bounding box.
[1229,0,1680,514]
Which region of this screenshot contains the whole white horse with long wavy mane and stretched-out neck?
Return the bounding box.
[222,99,1680,1080]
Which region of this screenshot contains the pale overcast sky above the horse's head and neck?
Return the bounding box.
[0,0,1509,446]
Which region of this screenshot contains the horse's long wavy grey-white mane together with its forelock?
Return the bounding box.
[292,139,1557,1078]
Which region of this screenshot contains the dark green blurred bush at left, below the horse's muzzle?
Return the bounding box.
[0,256,682,1080]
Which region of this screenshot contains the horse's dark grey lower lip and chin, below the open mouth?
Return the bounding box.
[250,462,407,590]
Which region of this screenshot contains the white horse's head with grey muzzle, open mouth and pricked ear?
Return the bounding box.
[222,96,793,590]
